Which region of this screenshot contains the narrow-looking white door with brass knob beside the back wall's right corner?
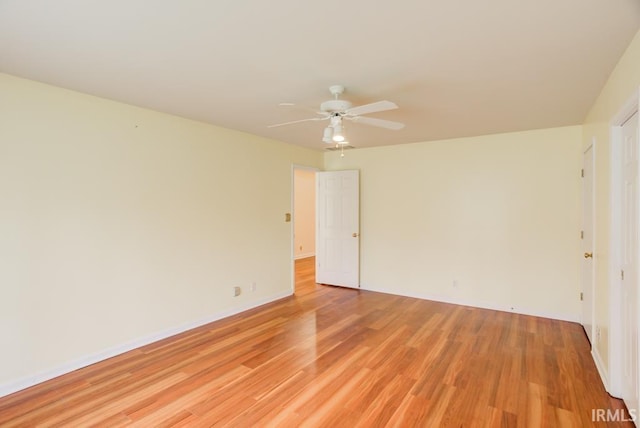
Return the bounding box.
[581,145,594,346]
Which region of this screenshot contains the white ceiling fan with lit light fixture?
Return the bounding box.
[268,85,404,145]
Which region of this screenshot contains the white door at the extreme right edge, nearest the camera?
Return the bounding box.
[620,112,640,412]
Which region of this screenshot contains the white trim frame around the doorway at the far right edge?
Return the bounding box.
[603,88,640,397]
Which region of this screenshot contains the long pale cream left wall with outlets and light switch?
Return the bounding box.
[0,74,322,395]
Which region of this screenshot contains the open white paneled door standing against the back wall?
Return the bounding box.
[316,171,360,288]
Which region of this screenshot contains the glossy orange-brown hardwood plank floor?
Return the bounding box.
[0,259,630,427]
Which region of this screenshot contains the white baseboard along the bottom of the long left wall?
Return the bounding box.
[0,290,292,397]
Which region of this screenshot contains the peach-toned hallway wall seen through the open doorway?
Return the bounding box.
[293,168,316,259]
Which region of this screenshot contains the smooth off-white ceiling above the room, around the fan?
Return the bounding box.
[0,0,640,149]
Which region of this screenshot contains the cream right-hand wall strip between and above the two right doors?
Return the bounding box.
[583,32,640,378]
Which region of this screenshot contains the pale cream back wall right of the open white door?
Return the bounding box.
[325,126,582,320]
